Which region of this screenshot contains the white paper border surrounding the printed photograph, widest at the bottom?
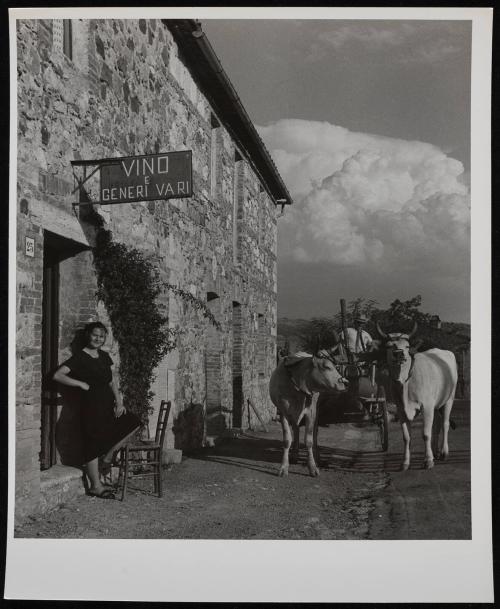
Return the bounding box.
[5,7,493,603]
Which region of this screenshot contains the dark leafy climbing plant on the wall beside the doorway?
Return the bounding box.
[94,227,220,422]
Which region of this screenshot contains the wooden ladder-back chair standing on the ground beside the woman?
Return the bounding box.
[118,400,172,501]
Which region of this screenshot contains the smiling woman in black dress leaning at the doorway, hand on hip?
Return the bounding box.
[54,322,140,499]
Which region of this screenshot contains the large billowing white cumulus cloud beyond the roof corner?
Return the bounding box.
[259,120,470,278]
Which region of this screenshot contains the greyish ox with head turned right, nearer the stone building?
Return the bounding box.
[269,353,347,476]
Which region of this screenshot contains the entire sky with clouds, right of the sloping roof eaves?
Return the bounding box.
[202,19,471,322]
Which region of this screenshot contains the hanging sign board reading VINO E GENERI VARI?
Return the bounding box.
[99,150,193,205]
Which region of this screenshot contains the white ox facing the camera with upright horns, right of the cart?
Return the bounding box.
[377,323,458,470]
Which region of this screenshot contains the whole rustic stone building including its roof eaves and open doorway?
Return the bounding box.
[16,19,291,518]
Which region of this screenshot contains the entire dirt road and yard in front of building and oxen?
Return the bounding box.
[15,406,470,539]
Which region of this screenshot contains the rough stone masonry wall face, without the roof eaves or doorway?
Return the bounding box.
[16,20,277,515]
